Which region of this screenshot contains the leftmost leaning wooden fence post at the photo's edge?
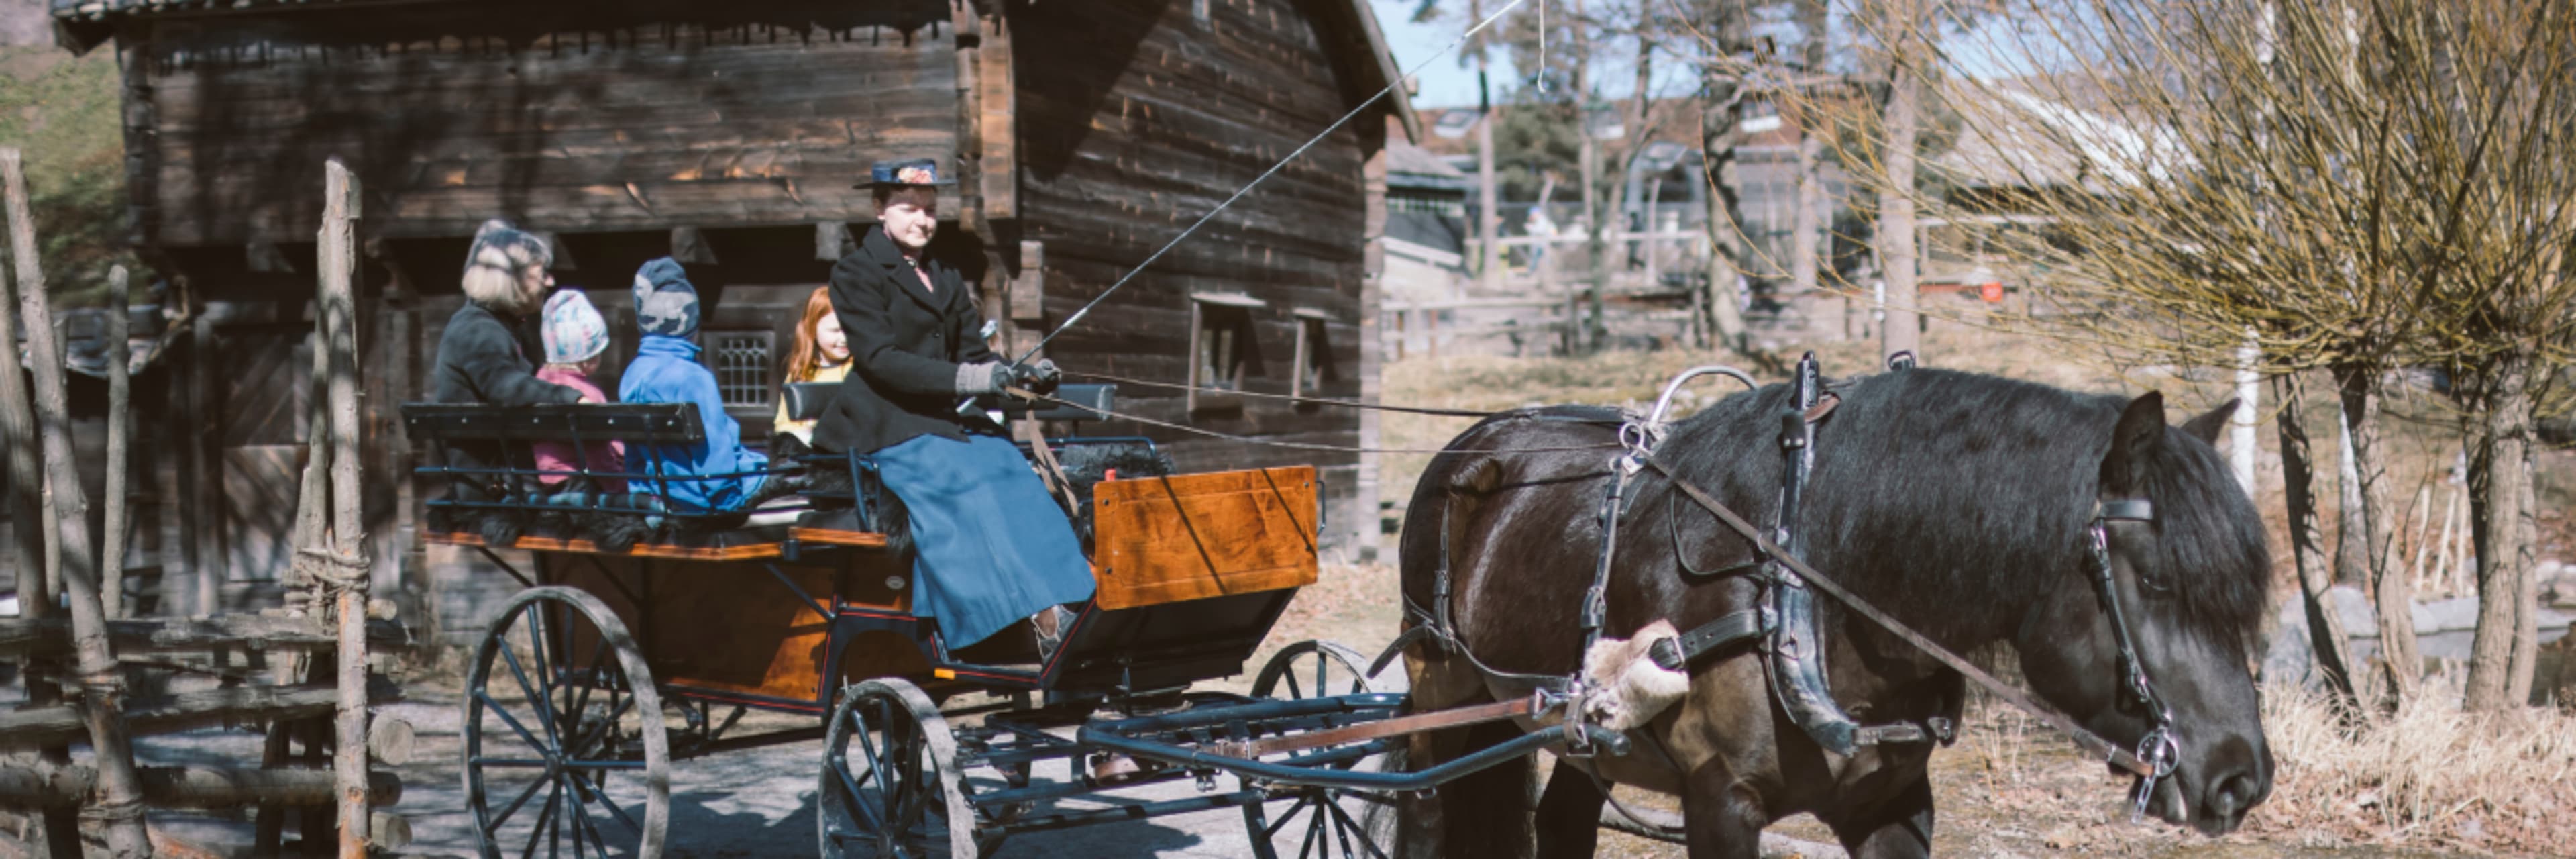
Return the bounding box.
[0,147,152,859]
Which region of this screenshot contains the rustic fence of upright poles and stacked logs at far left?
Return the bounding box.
[0,150,412,859]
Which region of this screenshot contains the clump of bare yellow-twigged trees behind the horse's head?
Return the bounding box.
[1924,0,2576,707]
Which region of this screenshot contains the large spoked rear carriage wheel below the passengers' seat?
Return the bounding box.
[464,588,669,859]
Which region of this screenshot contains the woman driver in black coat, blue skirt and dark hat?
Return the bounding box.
[814,160,1092,650]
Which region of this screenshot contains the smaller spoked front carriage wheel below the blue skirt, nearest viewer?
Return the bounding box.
[814,678,1002,859]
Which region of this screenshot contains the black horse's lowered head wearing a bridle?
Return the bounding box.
[2017,392,2272,836]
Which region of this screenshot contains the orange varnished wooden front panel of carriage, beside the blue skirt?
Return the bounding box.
[1092,464,1319,609]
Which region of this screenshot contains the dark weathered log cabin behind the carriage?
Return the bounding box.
[54,0,1419,637]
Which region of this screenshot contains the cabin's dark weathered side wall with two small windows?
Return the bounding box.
[1012,0,1383,544]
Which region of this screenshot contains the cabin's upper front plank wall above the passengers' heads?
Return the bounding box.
[123,0,956,245]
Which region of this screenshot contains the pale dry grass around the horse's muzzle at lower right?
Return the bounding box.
[1896,676,2576,856]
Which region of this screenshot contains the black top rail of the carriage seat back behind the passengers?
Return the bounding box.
[402,403,706,444]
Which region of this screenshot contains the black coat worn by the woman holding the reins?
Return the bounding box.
[814,227,1000,454]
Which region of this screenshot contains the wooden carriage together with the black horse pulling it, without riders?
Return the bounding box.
[405,358,2269,859]
